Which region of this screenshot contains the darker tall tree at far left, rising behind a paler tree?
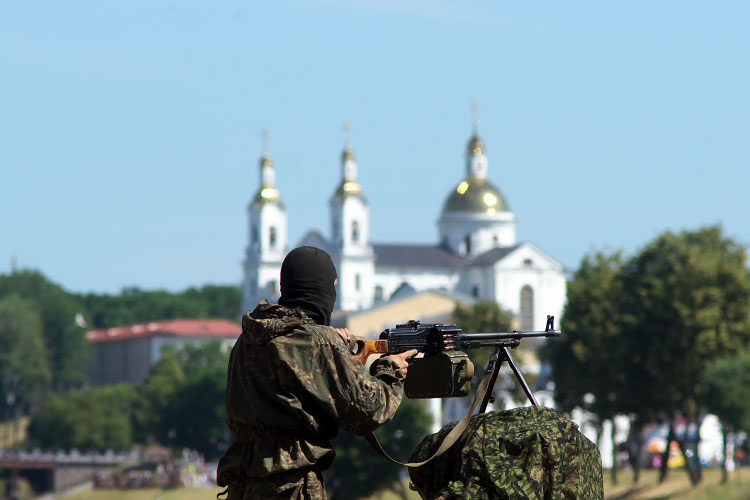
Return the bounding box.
[0,270,90,390]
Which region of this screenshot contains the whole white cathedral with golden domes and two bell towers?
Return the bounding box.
[243,120,566,333]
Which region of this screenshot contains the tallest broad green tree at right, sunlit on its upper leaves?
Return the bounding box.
[618,226,750,483]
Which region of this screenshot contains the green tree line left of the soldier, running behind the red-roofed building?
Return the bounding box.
[0,270,241,418]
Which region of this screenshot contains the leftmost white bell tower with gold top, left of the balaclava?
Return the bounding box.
[242,130,287,312]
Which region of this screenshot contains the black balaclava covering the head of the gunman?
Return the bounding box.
[279,247,336,325]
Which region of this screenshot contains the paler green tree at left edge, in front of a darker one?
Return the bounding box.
[0,294,50,416]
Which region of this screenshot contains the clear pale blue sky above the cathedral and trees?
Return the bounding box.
[0,0,750,293]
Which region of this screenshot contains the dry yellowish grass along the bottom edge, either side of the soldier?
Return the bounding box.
[64,467,750,500]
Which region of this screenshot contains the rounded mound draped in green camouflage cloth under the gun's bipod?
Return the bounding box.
[409,406,604,500]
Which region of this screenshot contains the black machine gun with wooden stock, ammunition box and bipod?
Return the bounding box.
[354,316,560,402]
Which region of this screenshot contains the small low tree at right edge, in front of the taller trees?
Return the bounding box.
[699,352,750,483]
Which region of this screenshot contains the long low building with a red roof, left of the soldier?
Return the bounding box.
[86,319,242,385]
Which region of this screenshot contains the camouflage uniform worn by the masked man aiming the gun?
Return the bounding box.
[217,301,403,500]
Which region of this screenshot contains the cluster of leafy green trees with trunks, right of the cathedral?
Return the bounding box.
[543,226,750,484]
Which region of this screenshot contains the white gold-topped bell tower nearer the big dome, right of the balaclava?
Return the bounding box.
[329,123,375,311]
